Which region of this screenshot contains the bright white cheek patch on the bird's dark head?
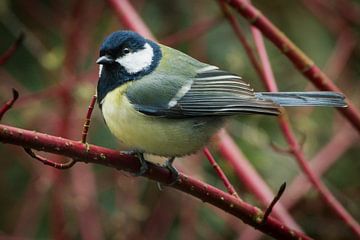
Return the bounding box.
[115,43,154,74]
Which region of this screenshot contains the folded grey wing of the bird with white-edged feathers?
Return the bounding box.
[130,66,279,118]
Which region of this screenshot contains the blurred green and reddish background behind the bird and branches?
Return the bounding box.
[0,0,360,239]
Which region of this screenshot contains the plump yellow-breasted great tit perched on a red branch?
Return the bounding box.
[96,30,346,180]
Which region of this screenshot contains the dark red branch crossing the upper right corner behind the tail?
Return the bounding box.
[227,0,360,132]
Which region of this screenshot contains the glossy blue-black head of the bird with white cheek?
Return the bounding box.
[96,31,162,104]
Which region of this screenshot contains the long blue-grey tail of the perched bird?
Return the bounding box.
[255,92,347,107]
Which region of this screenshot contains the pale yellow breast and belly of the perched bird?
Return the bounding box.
[102,82,222,156]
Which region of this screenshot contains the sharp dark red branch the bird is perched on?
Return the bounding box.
[0,125,310,239]
